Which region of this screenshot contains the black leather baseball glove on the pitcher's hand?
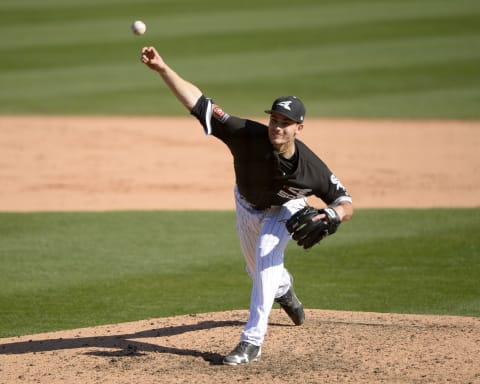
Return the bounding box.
[285,206,341,249]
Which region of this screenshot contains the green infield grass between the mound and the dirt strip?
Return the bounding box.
[0,209,480,337]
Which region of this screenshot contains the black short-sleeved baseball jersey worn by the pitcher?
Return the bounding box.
[192,96,351,209]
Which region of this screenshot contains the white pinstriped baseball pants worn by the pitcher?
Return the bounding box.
[234,188,306,346]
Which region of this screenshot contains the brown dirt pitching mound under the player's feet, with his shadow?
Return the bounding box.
[0,309,480,384]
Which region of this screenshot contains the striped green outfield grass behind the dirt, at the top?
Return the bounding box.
[0,0,480,119]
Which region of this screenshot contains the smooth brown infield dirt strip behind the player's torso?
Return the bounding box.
[0,116,480,211]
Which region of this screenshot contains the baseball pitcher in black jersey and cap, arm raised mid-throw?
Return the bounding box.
[141,47,353,365]
